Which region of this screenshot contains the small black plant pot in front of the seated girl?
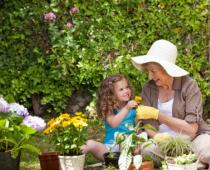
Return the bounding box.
[104,152,120,168]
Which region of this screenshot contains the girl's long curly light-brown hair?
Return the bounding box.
[96,74,133,118]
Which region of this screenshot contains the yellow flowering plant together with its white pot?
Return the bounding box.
[44,112,87,170]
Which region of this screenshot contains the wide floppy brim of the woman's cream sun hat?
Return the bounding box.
[131,55,189,77]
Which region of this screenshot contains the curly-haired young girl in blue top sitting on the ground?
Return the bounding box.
[81,75,138,161]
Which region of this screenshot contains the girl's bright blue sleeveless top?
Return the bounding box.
[104,108,136,144]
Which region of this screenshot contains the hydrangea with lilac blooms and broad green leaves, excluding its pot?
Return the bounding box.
[0,97,46,158]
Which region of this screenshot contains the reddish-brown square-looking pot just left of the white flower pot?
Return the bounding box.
[39,152,60,170]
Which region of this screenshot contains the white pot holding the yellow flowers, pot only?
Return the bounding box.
[58,155,85,170]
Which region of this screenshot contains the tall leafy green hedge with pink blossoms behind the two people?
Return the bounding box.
[0,0,210,115]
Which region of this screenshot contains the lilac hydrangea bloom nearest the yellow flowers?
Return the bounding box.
[23,116,46,131]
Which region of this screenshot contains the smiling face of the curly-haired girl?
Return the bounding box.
[114,79,131,102]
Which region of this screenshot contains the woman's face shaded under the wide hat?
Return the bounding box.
[145,64,173,87]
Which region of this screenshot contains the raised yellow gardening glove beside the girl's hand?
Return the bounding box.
[136,105,159,120]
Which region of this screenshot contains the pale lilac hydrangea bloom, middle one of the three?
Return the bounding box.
[8,103,29,117]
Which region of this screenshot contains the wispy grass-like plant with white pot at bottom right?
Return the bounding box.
[156,136,197,170]
